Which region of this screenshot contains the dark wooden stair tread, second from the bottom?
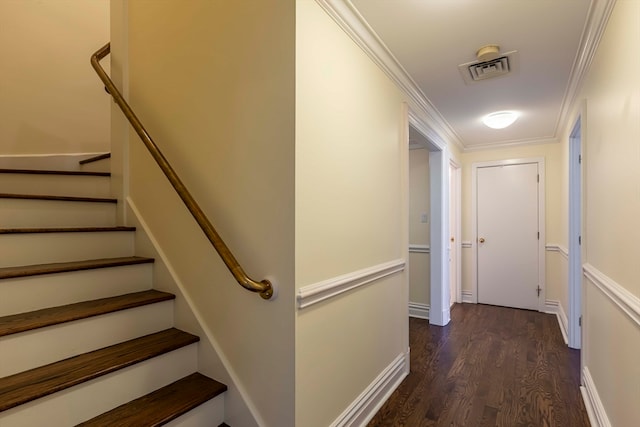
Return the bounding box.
[0,328,199,412]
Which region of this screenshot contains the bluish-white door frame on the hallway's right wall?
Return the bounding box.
[568,114,584,349]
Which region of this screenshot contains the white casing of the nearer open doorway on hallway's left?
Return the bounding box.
[409,110,451,326]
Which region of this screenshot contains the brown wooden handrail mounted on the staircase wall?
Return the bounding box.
[91,43,273,299]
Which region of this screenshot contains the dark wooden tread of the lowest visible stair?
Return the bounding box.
[77,372,227,427]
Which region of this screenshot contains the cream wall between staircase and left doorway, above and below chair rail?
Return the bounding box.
[296,0,408,427]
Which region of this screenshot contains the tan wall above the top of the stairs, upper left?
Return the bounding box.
[0,0,110,155]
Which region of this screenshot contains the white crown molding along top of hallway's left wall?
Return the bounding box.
[316,0,465,150]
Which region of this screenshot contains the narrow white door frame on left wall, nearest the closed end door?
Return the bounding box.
[449,159,462,303]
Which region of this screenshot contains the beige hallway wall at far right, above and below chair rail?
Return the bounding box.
[565,0,640,426]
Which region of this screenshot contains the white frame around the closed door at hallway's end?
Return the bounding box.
[471,157,546,311]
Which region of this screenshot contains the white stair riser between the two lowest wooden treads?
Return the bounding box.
[0,344,197,427]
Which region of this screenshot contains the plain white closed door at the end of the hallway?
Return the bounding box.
[476,163,540,310]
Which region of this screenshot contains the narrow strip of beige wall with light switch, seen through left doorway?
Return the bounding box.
[409,148,431,304]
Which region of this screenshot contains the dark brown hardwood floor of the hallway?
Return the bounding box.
[368,304,590,427]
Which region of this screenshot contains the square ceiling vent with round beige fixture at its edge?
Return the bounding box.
[458,44,518,84]
